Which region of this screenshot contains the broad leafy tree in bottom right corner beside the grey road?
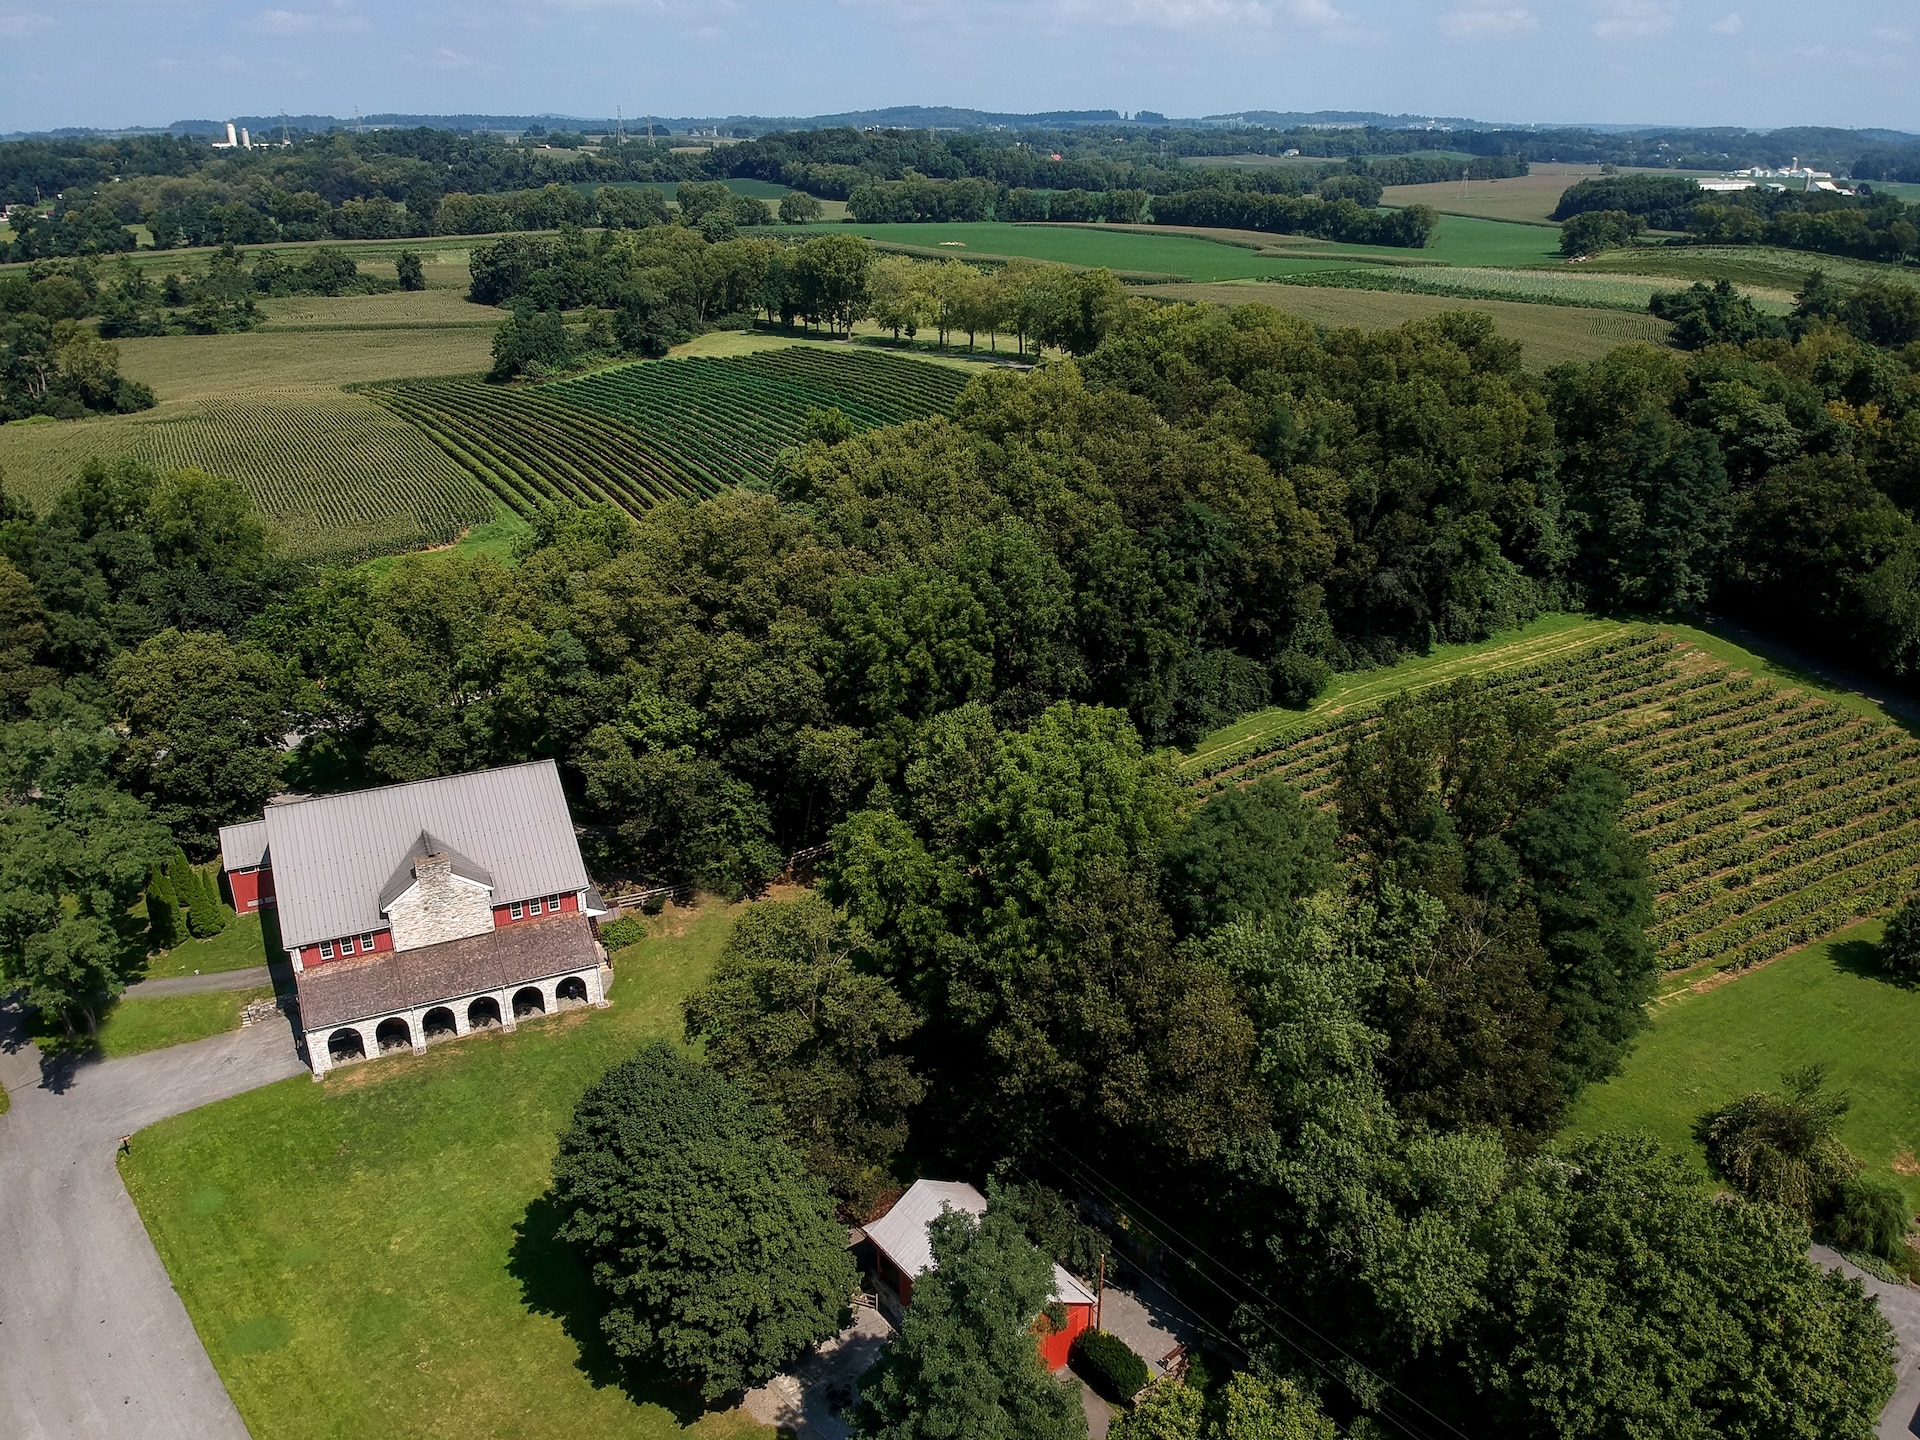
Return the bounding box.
[1467,1137,1895,1440]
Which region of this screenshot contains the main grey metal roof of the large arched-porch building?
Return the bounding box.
[263,760,588,948]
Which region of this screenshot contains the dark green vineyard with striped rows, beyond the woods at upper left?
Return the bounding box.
[365,346,968,511]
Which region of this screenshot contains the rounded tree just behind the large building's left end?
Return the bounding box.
[109,630,294,854]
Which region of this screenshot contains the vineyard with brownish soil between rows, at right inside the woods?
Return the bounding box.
[1185,626,1920,970]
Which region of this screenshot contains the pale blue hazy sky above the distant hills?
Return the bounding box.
[0,0,1920,131]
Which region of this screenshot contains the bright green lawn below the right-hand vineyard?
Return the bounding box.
[1567,922,1920,1210]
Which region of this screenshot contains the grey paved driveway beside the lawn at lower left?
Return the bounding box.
[0,1008,305,1440]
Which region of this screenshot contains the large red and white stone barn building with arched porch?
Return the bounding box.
[221,760,611,1079]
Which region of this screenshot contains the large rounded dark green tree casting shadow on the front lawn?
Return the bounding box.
[553,1041,854,1400]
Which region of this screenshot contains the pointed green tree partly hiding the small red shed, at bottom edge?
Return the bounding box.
[854,1206,1087,1440]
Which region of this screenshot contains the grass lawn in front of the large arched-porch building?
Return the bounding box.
[121,902,766,1440]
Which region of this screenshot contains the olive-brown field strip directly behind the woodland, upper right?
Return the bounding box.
[1135,282,1668,371]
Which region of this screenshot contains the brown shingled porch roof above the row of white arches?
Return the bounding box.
[296,916,599,1029]
